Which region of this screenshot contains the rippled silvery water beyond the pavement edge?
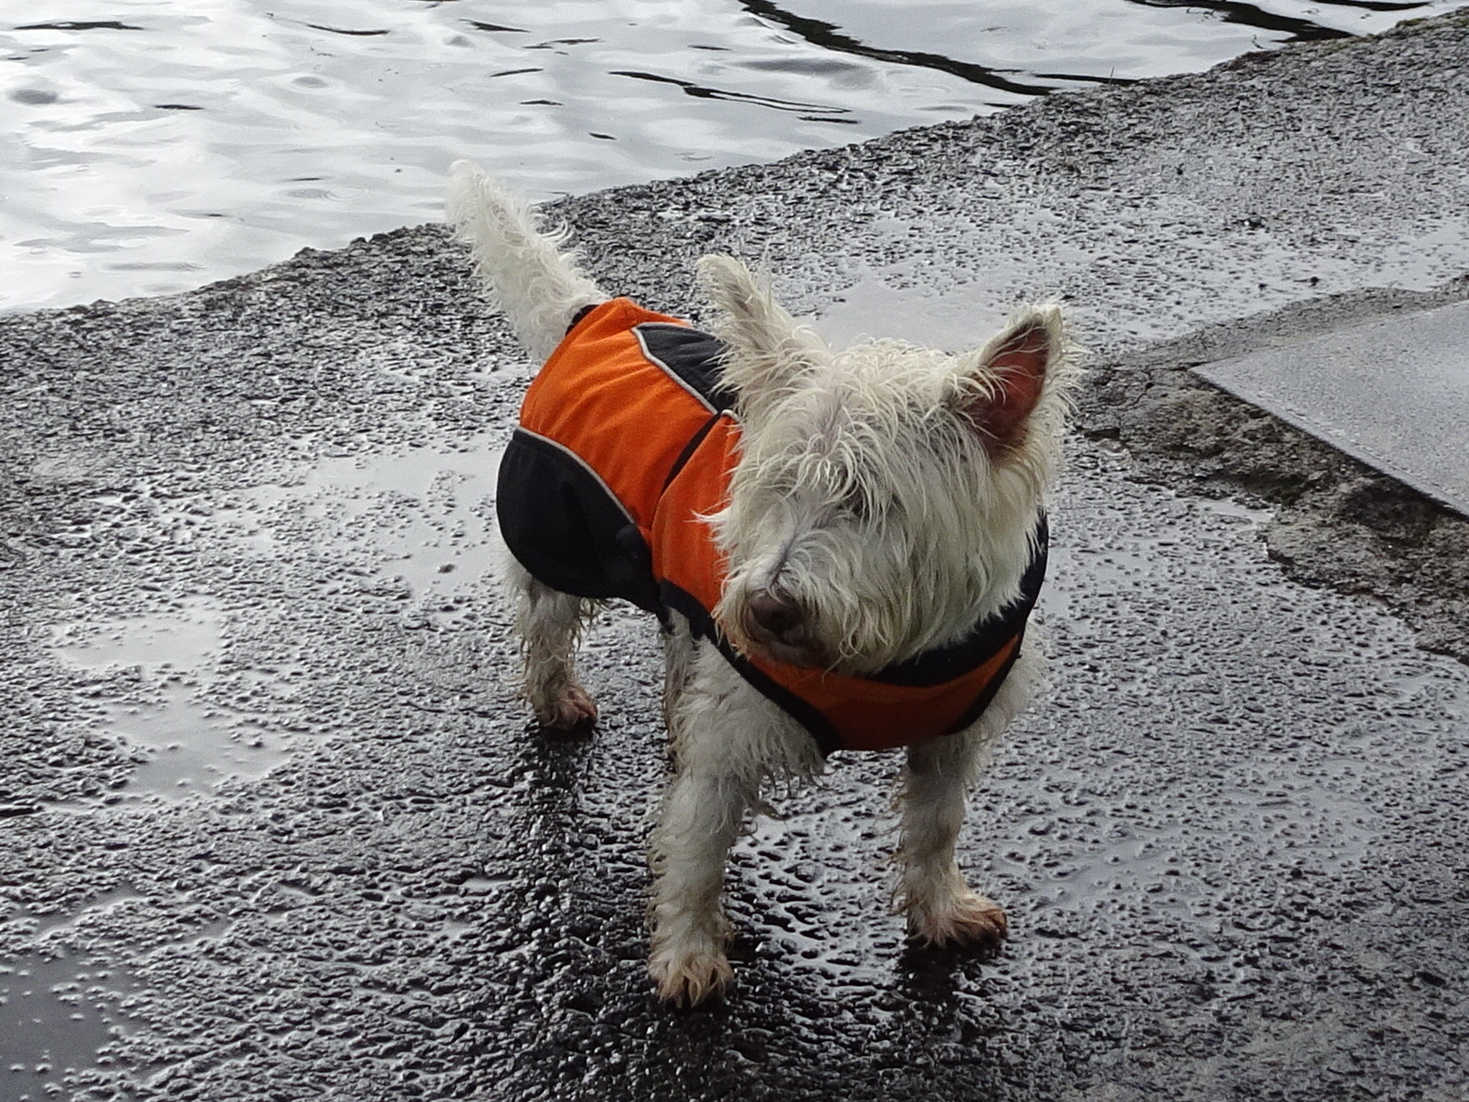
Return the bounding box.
[0,0,1469,309]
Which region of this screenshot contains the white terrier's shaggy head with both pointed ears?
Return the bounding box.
[699,257,1075,674]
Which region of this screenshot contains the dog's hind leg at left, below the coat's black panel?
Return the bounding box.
[505,554,596,730]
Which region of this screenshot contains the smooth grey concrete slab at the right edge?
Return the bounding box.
[1196,303,1469,516]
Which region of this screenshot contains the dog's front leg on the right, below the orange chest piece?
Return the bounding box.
[899,727,1006,949]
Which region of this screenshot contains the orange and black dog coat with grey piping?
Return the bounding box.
[497,298,1047,752]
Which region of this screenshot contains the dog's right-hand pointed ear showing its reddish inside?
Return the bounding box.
[955,306,1065,454]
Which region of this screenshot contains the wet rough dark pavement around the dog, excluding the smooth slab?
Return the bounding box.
[0,10,1469,1102]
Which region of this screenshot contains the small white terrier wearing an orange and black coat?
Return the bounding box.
[450,162,1075,1004]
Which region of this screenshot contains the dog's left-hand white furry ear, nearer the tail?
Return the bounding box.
[699,256,826,398]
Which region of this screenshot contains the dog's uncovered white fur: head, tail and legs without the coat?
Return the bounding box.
[450,162,1075,1004]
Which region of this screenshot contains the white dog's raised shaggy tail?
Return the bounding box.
[448,160,607,361]
